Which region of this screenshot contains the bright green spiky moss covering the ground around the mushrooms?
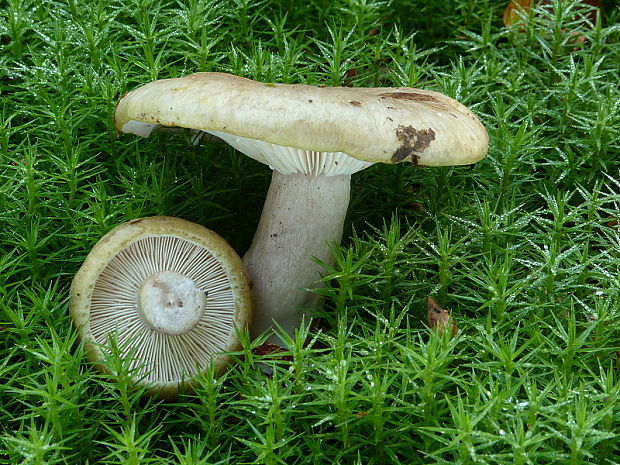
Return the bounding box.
[0,0,620,465]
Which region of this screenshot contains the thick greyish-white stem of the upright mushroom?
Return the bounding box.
[243,171,351,342]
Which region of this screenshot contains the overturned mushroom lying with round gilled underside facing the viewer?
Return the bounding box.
[70,216,252,398]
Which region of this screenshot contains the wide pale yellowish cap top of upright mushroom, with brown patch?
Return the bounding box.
[115,73,489,166]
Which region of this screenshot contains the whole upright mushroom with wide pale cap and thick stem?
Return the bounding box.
[115,73,488,340]
